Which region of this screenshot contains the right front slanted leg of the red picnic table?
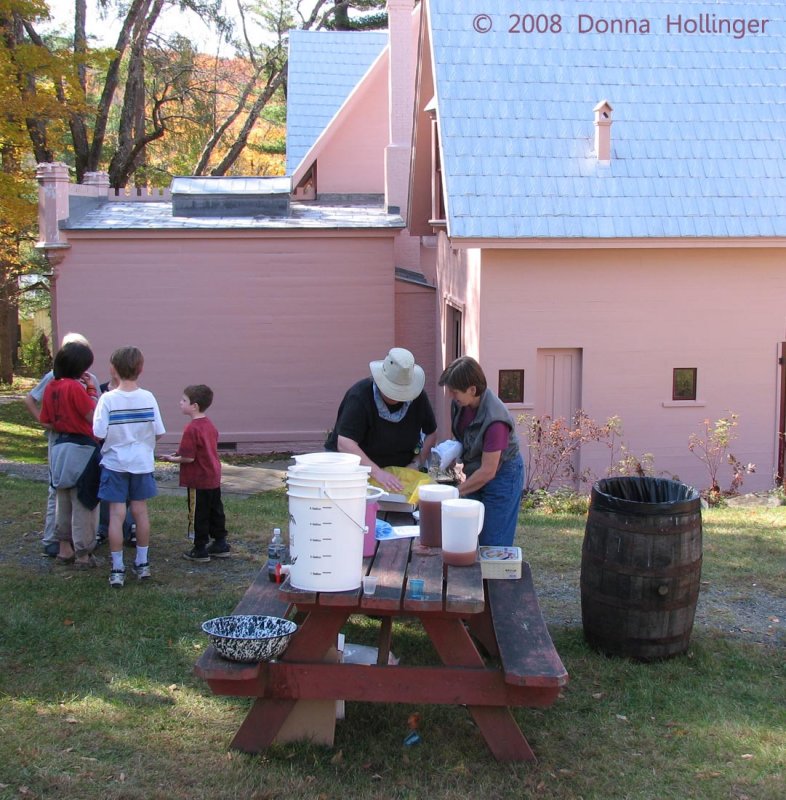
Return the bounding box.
[421,617,536,761]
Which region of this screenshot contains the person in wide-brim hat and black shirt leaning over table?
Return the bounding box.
[325,347,437,492]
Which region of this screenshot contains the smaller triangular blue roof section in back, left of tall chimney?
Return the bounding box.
[287,30,387,175]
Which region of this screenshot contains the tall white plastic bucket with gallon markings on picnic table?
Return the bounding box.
[287,453,371,592]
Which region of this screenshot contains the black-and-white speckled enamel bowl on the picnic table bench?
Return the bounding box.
[202,614,297,662]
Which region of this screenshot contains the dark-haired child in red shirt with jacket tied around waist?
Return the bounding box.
[39,342,98,567]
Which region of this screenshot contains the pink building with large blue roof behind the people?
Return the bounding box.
[39,0,786,489]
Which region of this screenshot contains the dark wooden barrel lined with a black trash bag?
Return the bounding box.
[581,478,702,661]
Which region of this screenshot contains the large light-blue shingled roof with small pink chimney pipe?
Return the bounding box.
[428,0,786,239]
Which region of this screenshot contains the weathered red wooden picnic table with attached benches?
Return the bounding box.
[195,538,568,761]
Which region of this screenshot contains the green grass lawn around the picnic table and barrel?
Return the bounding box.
[0,400,786,800]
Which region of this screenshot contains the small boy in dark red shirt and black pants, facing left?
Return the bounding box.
[161,384,231,561]
